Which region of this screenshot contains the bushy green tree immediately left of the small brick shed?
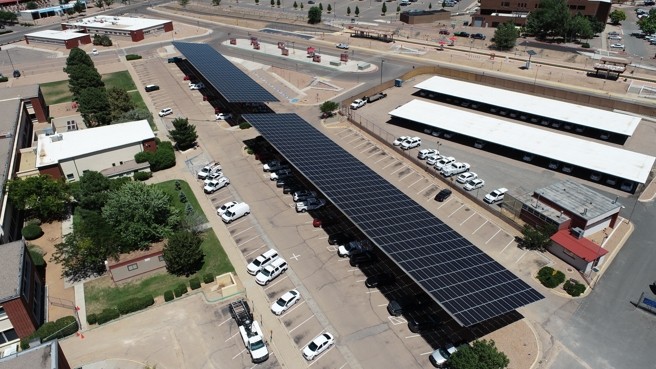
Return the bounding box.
[50,231,107,282]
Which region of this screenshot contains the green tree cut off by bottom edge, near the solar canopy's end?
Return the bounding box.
[448,340,510,369]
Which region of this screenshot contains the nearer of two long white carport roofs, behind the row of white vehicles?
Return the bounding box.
[389,100,656,183]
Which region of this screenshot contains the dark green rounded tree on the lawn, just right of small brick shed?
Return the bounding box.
[163,230,205,277]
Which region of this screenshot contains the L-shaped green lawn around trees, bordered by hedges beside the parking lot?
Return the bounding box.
[84,180,229,314]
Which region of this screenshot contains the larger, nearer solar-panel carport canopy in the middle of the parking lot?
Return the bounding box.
[243,114,544,326]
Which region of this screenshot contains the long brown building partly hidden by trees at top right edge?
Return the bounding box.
[471,0,611,27]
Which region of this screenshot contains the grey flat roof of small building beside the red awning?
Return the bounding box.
[534,179,622,220]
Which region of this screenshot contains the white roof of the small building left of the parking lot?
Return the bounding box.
[36,119,155,168]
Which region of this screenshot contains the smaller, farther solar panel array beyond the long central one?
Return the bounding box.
[173,41,278,103]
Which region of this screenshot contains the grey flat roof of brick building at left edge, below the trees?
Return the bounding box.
[0,240,25,302]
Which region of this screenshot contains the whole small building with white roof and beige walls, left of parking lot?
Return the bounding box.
[35,120,157,181]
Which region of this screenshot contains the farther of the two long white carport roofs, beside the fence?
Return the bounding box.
[415,76,640,136]
